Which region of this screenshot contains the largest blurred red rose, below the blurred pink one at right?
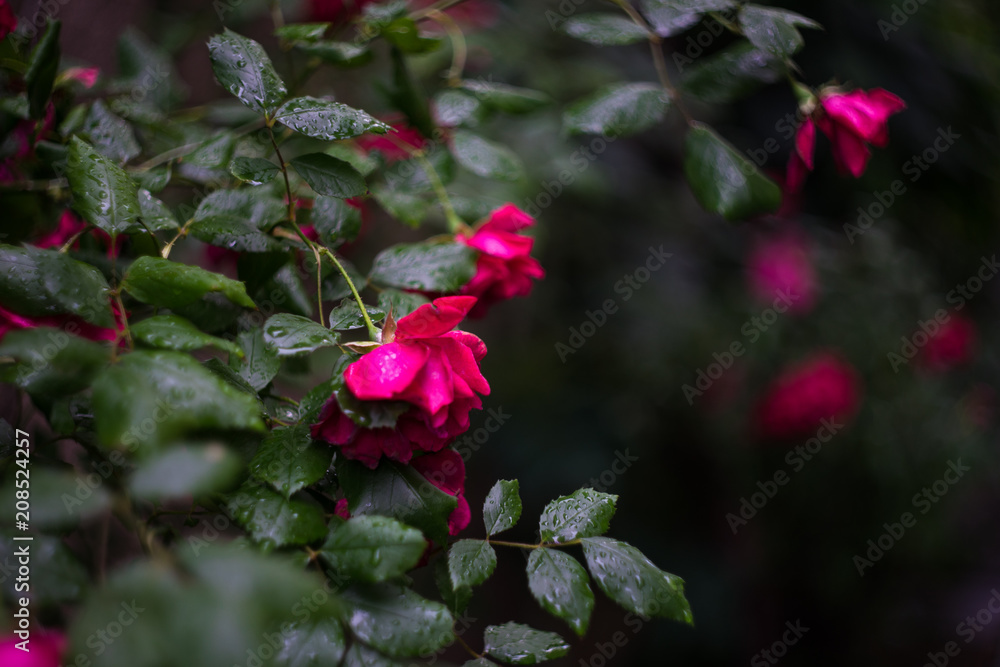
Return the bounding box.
[756,352,861,440]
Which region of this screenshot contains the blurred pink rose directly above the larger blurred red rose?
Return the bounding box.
[747,233,816,313]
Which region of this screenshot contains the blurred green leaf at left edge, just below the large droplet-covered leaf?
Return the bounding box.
[0,323,111,397]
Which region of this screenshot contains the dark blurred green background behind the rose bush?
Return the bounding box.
[14,0,1000,667]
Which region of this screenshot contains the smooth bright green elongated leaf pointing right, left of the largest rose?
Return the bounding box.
[122,256,256,308]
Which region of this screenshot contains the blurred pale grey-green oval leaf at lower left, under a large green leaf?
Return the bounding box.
[129,443,243,502]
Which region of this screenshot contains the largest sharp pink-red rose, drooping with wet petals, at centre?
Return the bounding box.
[312,296,490,468]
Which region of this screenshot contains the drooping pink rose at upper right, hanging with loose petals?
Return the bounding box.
[788,88,906,190]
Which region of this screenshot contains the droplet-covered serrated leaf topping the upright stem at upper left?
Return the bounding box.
[208,28,288,115]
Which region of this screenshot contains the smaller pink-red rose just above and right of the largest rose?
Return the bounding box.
[455,204,545,317]
